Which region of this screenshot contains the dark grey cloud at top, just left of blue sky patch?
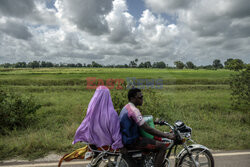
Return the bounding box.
[59,0,112,35]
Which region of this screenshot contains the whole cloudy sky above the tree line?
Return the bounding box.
[0,0,250,65]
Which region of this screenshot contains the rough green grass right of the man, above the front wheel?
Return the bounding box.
[157,89,250,150]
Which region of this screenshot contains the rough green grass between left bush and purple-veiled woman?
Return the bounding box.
[0,88,92,159]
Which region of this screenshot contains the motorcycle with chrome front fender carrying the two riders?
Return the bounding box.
[85,121,214,167]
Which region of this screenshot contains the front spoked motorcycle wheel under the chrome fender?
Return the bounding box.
[178,148,214,167]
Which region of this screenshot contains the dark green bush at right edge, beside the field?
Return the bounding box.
[230,66,250,111]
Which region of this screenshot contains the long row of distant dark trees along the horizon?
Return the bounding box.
[0,58,246,71]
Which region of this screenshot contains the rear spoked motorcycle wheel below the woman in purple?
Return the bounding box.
[96,156,133,167]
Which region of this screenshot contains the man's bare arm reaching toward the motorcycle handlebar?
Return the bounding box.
[140,122,175,140]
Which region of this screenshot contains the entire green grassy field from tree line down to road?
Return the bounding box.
[0,68,250,159]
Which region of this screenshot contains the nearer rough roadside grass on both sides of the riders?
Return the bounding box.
[0,85,250,160]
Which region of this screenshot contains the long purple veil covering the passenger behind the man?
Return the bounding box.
[73,86,123,149]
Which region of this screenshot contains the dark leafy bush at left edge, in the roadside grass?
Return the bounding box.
[0,90,41,135]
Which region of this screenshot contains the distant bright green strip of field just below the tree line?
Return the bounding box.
[0,68,234,86]
